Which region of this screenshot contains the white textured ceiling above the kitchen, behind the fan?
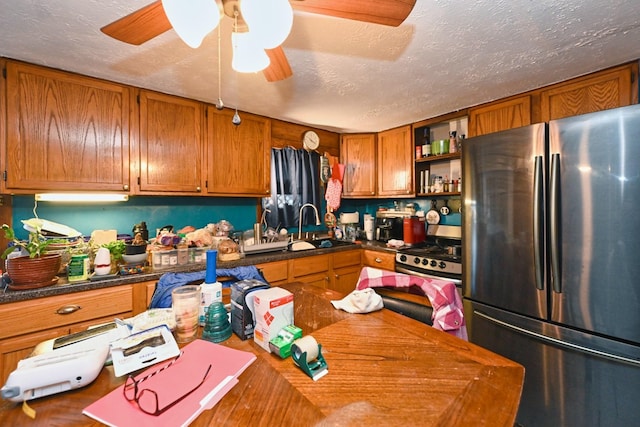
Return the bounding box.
[0,0,640,132]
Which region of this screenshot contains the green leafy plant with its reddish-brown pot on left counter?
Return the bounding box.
[2,224,61,289]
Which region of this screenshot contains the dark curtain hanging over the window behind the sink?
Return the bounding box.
[262,147,321,229]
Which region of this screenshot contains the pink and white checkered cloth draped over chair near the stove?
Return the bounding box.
[356,267,468,340]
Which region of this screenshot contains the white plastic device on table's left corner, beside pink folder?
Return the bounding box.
[0,324,129,402]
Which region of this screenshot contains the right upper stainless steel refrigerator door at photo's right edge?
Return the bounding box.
[549,105,640,344]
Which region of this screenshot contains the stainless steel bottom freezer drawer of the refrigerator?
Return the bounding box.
[465,300,640,427]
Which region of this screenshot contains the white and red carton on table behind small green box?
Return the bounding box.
[253,287,293,353]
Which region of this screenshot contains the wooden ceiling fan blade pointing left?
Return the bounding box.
[100,0,171,45]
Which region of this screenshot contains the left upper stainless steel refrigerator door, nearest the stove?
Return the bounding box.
[462,124,547,318]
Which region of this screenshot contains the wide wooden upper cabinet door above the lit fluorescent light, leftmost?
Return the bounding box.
[4,61,131,193]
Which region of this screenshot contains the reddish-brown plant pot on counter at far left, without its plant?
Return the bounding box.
[7,254,61,288]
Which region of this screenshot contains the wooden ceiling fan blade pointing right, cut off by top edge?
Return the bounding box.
[291,0,416,27]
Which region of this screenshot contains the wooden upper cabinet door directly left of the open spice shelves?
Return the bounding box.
[377,125,415,197]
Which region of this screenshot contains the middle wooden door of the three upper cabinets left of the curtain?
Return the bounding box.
[132,90,204,195]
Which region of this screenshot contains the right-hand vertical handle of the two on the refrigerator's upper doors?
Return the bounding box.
[549,153,562,293]
